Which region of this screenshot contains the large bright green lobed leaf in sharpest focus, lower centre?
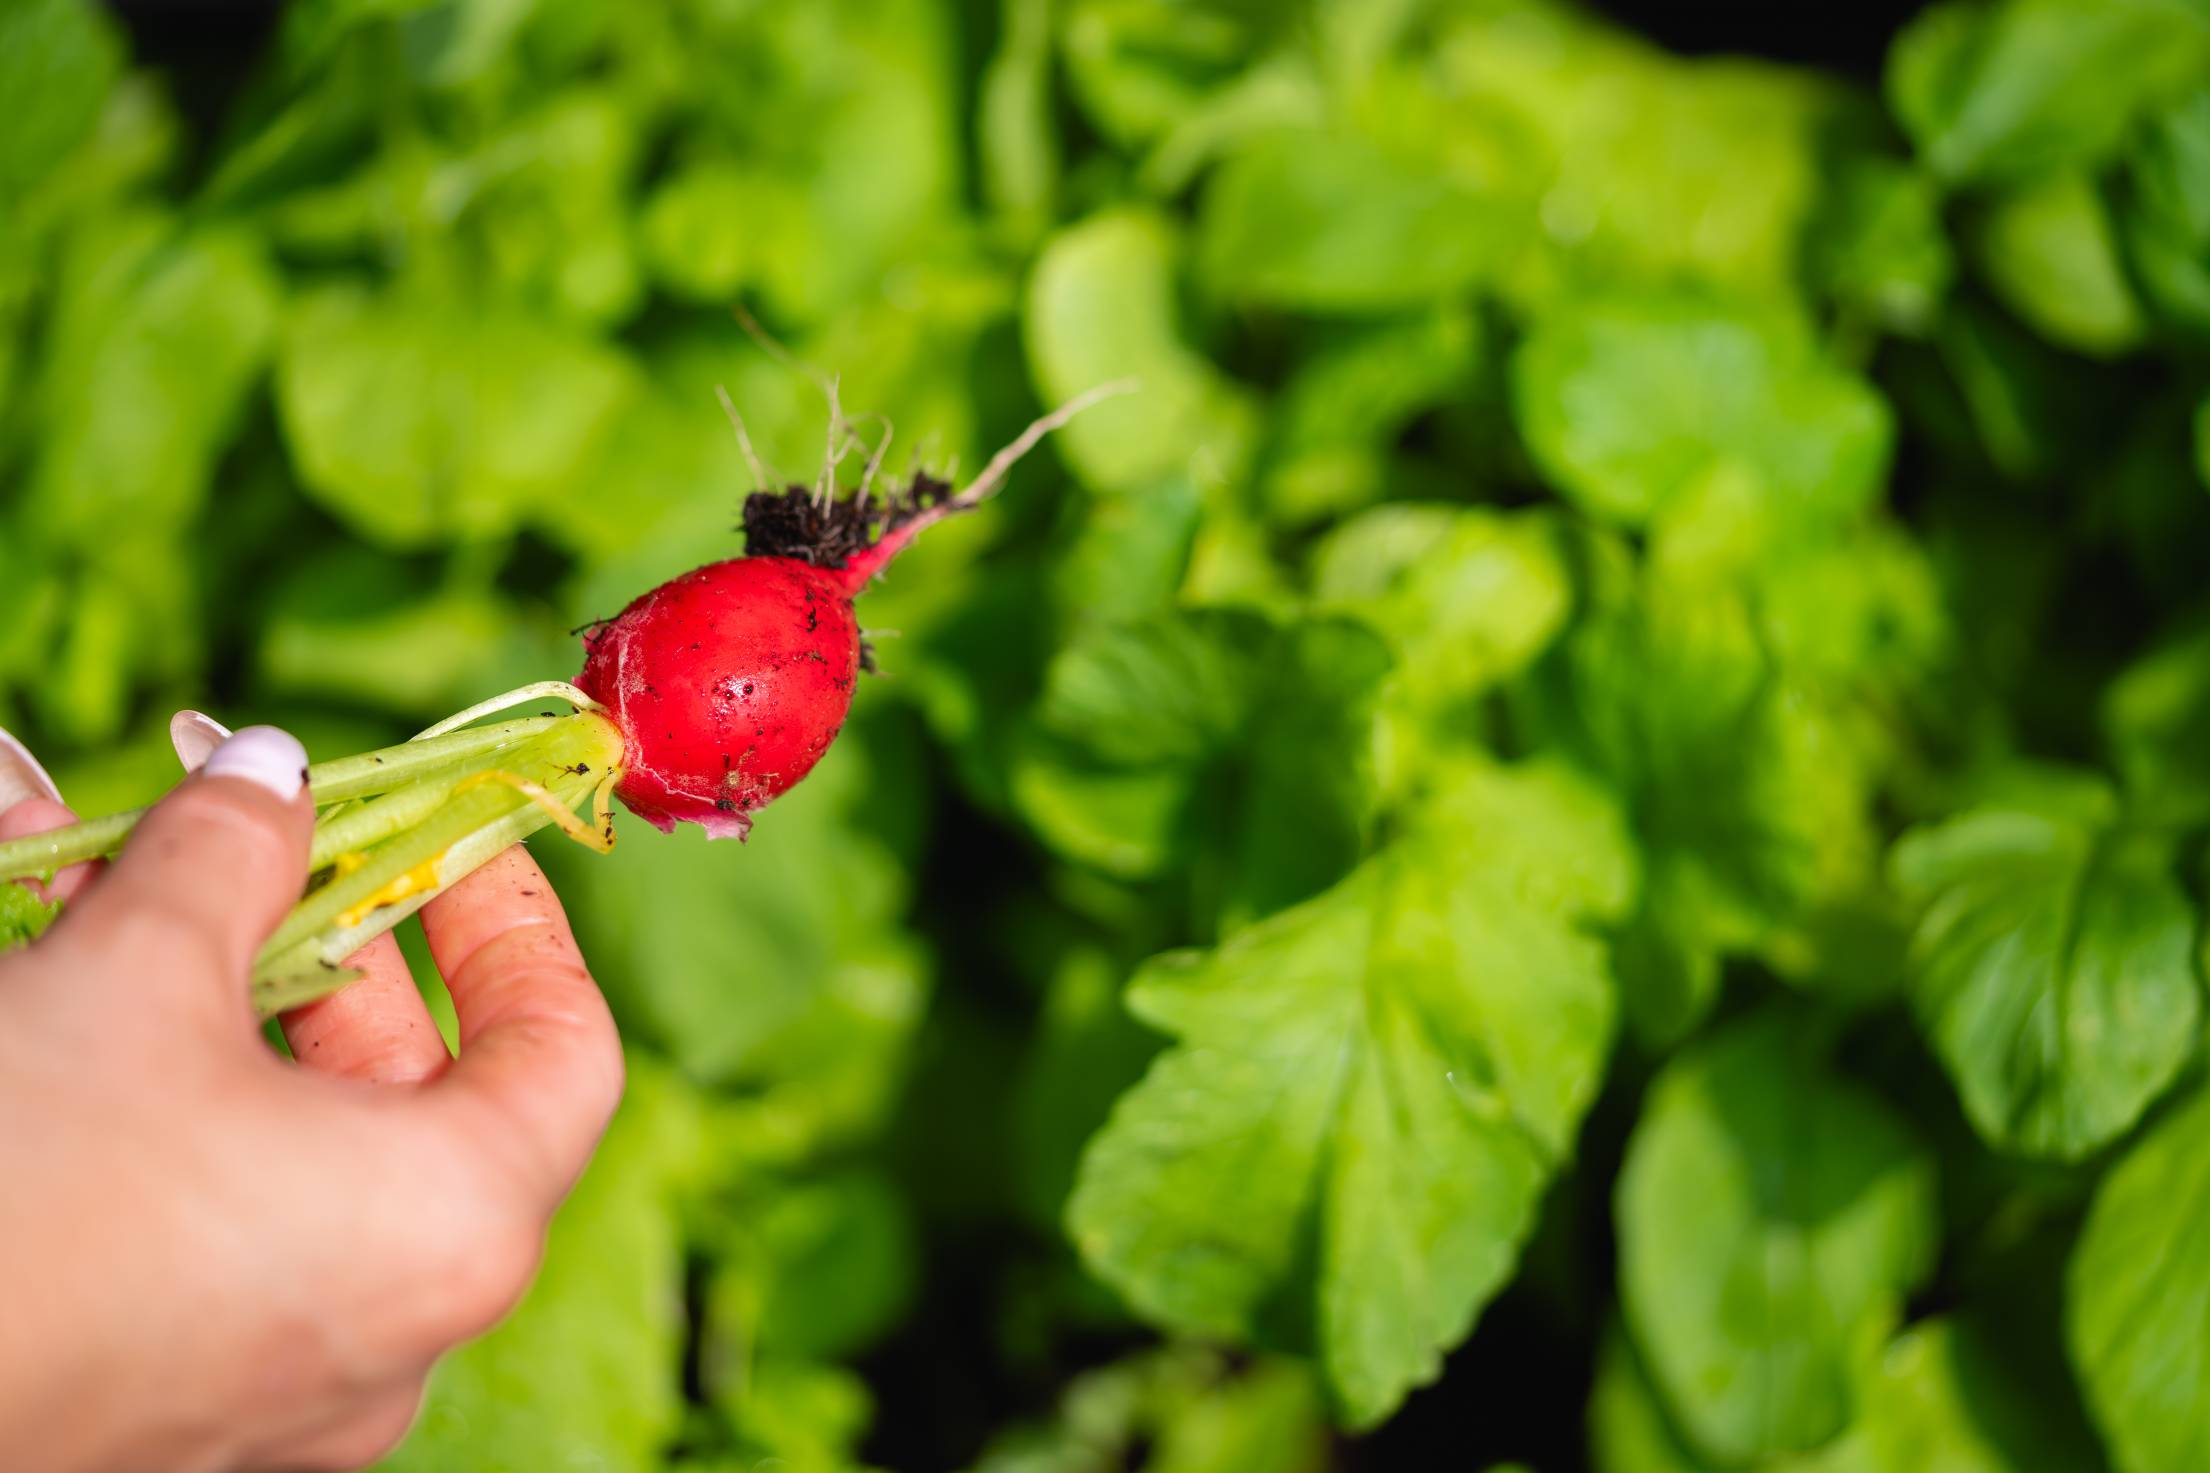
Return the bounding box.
[1067,766,1631,1424]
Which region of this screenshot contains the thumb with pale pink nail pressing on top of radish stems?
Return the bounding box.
[53,727,314,1009]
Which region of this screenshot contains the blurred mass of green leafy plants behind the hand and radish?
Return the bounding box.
[0,0,2210,1473]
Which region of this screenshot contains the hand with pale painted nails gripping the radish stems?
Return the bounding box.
[0,718,621,1473]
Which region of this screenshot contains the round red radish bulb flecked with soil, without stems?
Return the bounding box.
[575,556,870,839]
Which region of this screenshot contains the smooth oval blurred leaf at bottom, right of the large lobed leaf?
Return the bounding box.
[1616,1014,1938,1464]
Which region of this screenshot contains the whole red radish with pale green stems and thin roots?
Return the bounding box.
[0,382,1132,1016]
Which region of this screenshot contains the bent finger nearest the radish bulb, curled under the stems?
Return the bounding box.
[422,848,621,1215]
